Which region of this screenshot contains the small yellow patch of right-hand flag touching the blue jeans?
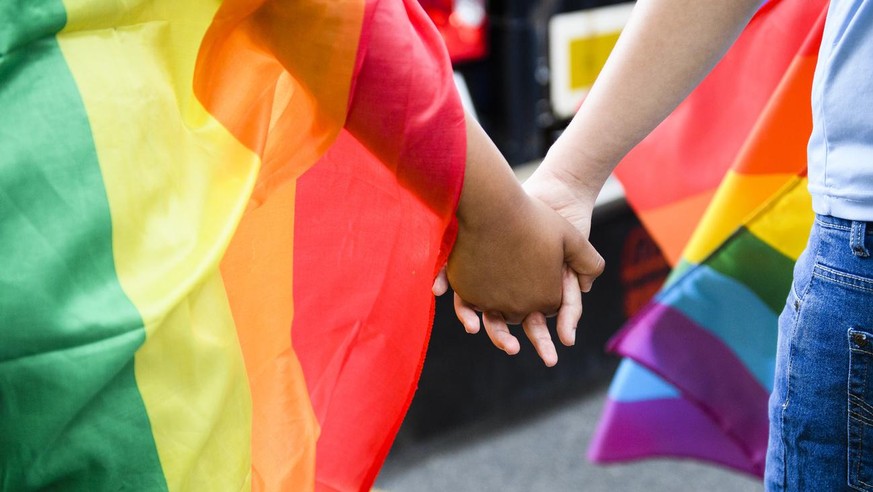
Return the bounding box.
[746,178,815,260]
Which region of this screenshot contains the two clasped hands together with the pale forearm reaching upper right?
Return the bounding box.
[434,0,761,365]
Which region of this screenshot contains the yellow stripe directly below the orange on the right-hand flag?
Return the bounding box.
[682,170,796,263]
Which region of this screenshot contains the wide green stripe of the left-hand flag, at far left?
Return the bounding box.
[0,5,166,491]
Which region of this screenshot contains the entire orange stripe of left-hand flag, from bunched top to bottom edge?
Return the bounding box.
[194,0,364,490]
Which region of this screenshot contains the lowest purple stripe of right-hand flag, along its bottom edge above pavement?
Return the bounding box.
[588,398,764,477]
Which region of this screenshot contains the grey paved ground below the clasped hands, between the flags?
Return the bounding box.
[376,388,762,492]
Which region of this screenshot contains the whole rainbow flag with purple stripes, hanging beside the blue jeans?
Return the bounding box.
[589,0,826,476]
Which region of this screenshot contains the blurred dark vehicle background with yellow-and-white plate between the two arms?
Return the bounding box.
[420,0,631,165]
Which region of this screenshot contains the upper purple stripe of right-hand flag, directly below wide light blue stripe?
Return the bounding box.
[609,302,769,463]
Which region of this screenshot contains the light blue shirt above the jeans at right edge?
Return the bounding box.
[808,0,873,222]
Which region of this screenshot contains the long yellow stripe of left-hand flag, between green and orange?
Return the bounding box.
[58,0,259,490]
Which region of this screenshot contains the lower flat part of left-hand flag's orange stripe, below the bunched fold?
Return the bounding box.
[221,182,318,490]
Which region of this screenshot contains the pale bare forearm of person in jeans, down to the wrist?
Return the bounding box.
[544,0,760,194]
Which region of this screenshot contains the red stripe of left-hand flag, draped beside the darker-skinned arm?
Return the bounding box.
[293,0,466,490]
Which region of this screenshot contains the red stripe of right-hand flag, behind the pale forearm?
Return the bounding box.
[616,0,825,210]
